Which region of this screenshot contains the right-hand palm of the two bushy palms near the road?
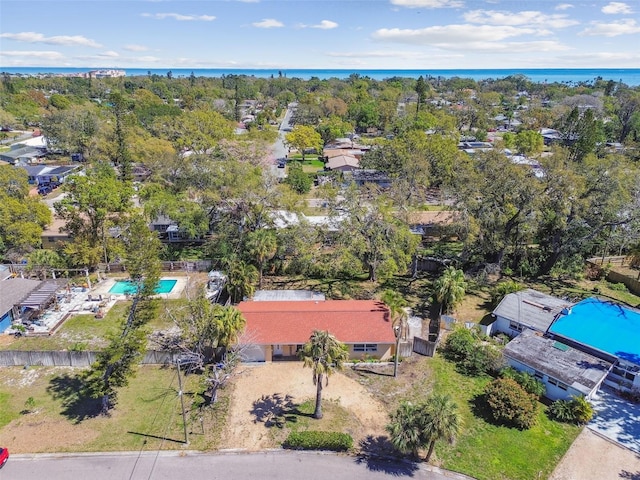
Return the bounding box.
[423,393,460,462]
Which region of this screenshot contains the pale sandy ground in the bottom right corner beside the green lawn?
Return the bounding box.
[549,428,640,480]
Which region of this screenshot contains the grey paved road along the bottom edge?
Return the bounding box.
[0,451,466,480]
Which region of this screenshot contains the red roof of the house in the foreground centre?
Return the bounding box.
[238,300,395,345]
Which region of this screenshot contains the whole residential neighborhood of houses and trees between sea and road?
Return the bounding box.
[0,66,640,480]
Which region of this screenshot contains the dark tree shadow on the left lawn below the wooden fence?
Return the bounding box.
[47,373,102,424]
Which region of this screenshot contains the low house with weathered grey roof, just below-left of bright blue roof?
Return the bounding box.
[502,329,612,400]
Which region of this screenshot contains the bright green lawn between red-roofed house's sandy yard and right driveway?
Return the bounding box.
[346,355,581,480]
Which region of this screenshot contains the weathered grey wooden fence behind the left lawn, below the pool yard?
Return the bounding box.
[0,350,180,367]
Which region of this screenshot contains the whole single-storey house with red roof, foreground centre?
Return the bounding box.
[238,300,396,362]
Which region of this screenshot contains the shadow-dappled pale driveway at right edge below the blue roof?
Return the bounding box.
[587,387,640,454]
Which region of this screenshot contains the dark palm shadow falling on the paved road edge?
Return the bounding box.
[355,435,420,477]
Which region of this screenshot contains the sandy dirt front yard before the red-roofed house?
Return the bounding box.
[221,362,389,450]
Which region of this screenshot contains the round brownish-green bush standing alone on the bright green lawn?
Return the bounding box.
[485,378,538,430]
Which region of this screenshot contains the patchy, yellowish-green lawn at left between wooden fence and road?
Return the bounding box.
[0,366,230,453]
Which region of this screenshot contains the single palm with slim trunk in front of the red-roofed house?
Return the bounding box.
[298,330,349,419]
